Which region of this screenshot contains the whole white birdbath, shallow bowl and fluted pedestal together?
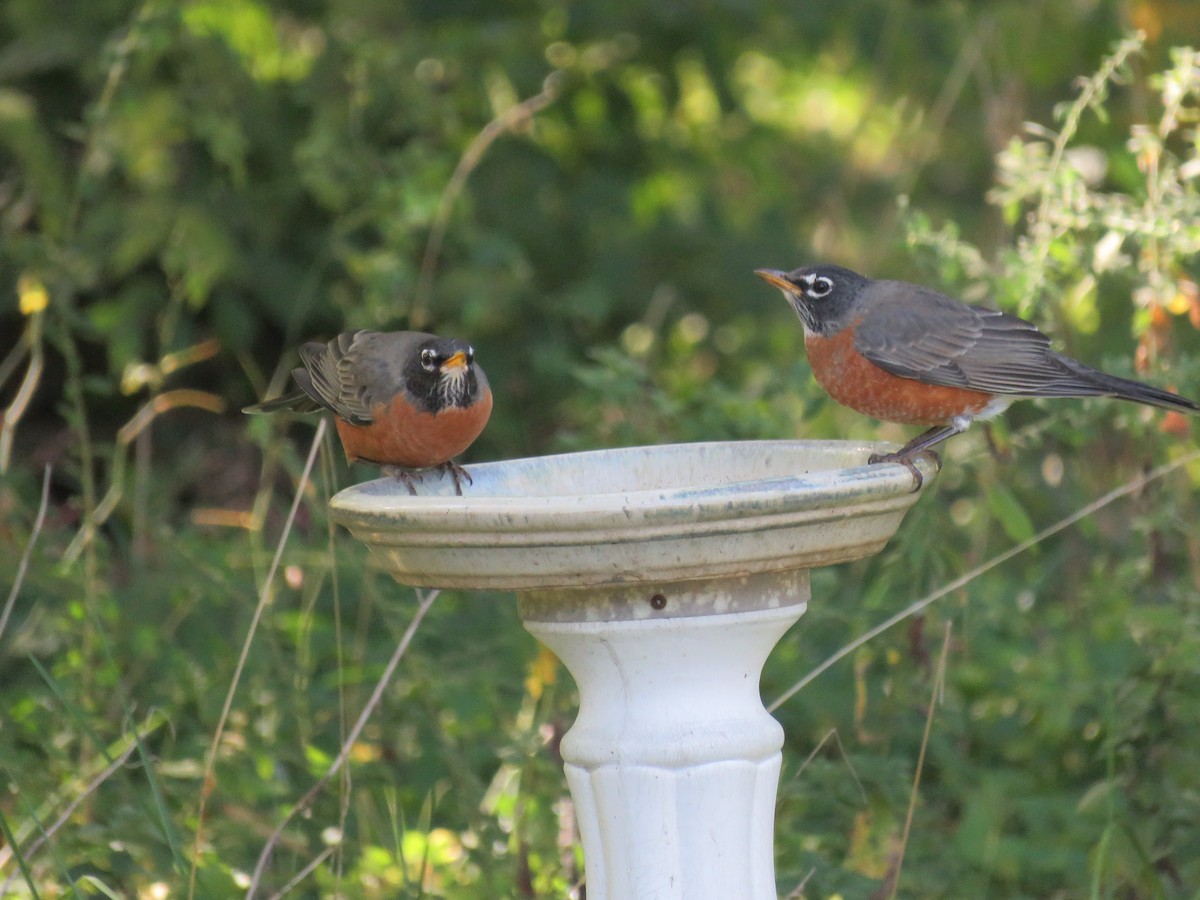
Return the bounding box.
[330,440,936,900]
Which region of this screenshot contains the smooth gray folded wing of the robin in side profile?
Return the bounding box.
[854,281,1112,397]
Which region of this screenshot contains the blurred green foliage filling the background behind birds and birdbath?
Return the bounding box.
[0,0,1200,898]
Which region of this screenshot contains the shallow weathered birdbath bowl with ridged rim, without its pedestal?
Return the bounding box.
[330,440,937,592]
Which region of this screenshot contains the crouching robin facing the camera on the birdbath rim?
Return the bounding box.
[242,331,492,494]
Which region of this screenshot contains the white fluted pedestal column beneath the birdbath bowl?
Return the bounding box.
[520,569,809,900]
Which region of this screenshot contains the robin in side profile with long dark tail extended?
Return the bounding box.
[755,265,1200,488]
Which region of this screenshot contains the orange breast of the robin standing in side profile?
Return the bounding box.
[804,326,995,426]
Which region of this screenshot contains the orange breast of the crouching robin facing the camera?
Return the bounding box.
[336,389,492,469]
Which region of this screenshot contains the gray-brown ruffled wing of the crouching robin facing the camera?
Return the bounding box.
[293,331,432,425]
